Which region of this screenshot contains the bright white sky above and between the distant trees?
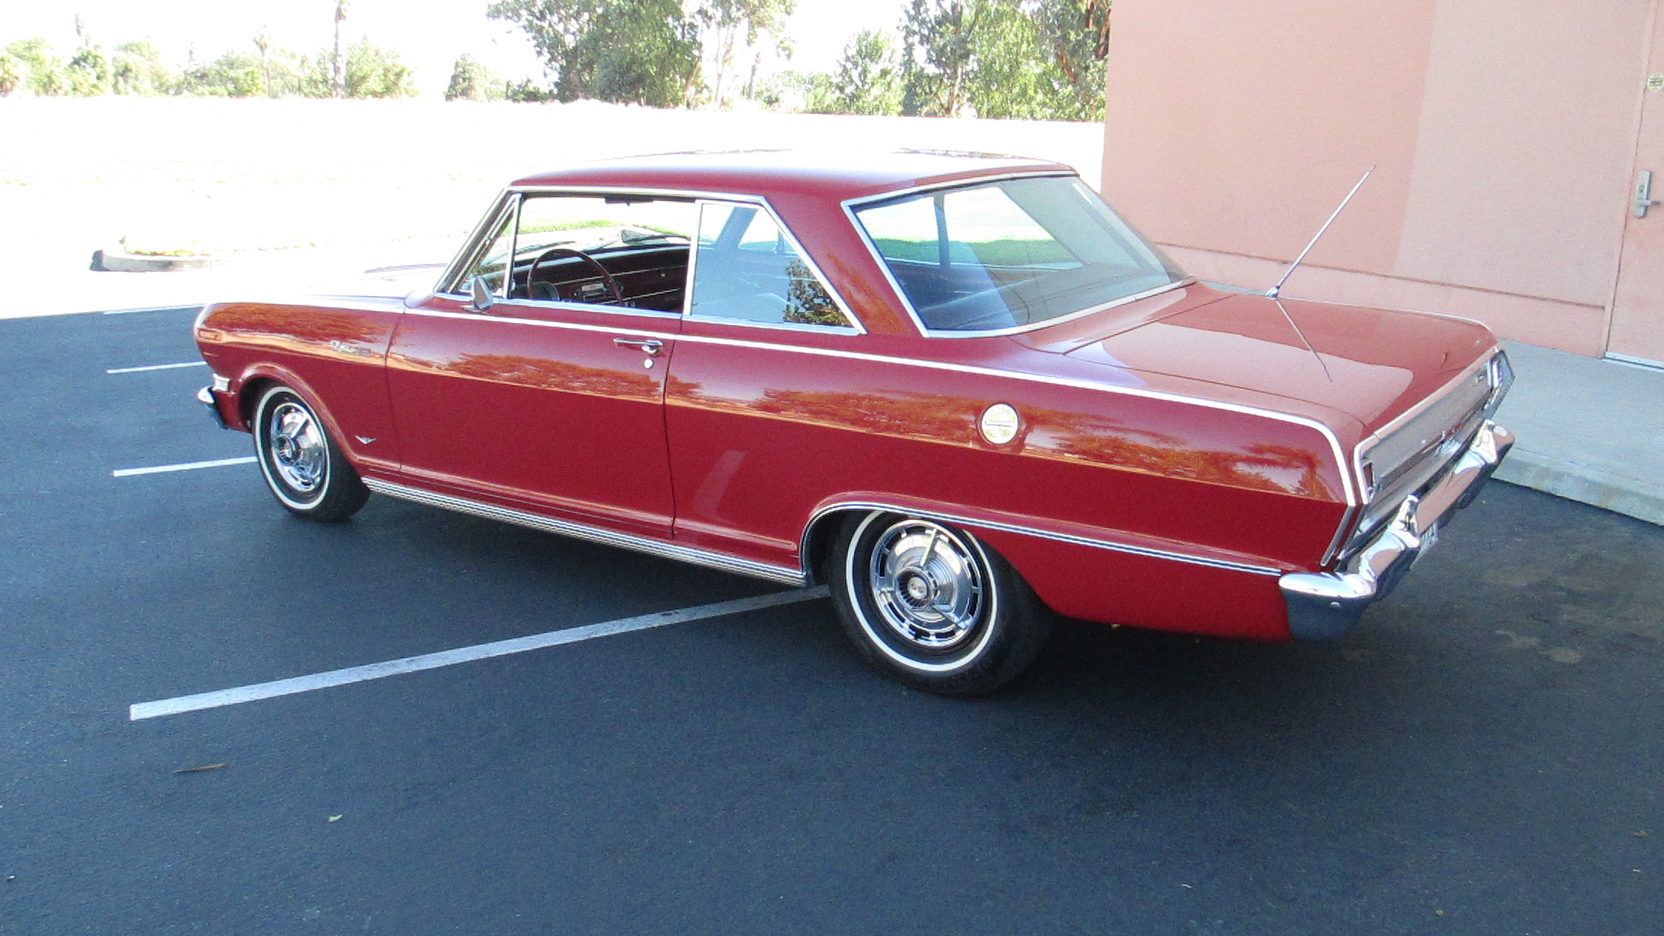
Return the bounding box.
[0,0,907,95]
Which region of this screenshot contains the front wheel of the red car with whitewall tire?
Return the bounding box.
[253,383,369,523]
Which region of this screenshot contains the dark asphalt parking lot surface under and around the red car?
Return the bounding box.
[0,310,1664,934]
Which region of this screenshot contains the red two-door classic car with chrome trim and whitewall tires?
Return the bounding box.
[196,152,1513,693]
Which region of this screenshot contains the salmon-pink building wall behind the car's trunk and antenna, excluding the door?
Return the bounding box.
[1103,0,1664,355]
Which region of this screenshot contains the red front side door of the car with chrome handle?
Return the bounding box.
[388,197,692,538]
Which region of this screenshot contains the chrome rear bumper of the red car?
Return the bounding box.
[1278,420,1514,640]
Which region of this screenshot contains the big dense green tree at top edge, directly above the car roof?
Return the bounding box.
[488,0,699,107]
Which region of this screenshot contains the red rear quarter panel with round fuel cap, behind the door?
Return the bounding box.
[666,321,1345,592]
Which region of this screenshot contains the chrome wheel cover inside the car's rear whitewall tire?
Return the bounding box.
[867,520,987,653]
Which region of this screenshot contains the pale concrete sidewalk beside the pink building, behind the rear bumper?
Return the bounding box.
[1496,341,1664,525]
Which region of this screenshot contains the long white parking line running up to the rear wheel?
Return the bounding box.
[126,585,827,721]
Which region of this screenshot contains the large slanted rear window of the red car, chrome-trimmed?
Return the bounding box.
[855,177,1188,331]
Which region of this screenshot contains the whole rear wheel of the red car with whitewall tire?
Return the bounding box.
[830,511,1050,695]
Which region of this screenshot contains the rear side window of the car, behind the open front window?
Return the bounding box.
[689,202,852,328]
